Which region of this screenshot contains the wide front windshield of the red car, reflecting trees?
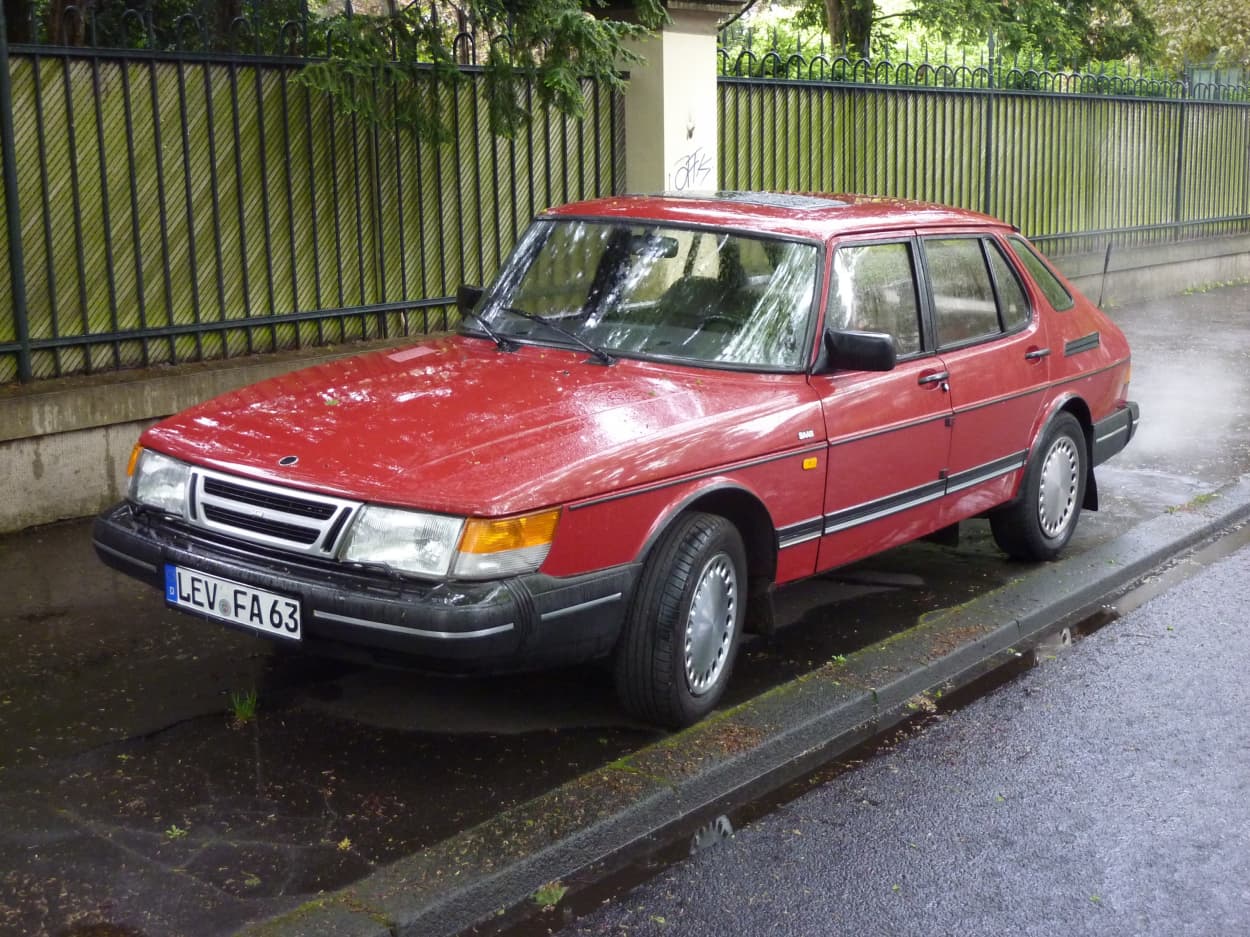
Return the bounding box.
[478,220,818,370]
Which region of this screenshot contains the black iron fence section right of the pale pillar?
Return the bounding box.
[720,49,1250,255]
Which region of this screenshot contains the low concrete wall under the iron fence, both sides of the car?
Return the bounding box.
[0,236,1250,532]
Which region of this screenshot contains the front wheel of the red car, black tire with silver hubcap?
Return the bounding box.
[615,513,746,728]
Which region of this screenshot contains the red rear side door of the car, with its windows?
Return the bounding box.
[920,232,1050,522]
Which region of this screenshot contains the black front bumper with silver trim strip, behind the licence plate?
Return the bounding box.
[93,502,639,672]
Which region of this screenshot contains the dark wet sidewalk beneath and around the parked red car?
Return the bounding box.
[0,286,1250,936]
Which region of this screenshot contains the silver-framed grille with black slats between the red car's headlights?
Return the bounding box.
[189,469,360,556]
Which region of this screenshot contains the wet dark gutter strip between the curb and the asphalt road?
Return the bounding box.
[460,523,1250,937]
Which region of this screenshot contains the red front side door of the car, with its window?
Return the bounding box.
[811,237,950,568]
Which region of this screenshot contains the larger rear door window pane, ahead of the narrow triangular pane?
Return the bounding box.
[925,237,1001,347]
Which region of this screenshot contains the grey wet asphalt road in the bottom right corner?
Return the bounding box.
[561,537,1250,937]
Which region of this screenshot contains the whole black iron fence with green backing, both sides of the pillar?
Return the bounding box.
[7,11,1250,385]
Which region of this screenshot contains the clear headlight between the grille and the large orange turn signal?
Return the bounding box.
[340,505,464,577]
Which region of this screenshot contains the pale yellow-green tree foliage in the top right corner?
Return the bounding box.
[1145,0,1250,67]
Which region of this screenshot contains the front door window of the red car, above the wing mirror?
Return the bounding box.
[826,241,920,357]
